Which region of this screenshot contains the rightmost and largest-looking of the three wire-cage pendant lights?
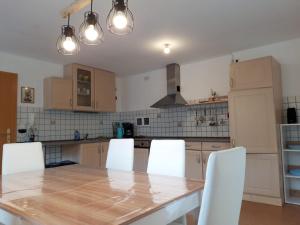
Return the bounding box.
[106,0,134,35]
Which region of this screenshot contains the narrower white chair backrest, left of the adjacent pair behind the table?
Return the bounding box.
[106,139,134,171]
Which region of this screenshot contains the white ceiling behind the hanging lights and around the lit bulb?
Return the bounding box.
[0,0,300,76]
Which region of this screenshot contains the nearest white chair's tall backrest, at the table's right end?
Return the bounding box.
[198,147,246,225]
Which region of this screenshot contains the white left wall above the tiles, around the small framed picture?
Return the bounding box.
[0,52,63,107]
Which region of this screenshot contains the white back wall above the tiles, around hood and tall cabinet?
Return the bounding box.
[118,39,300,111]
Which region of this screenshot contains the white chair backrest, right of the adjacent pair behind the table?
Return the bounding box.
[147,140,185,177]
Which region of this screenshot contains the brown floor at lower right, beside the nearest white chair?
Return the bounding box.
[239,202,300,225]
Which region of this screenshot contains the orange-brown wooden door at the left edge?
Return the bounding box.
[0,72,18,172]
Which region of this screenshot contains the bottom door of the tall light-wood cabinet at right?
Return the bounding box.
[244,154,280,197]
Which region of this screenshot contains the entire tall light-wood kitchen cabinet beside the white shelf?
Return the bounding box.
[228,57,282,205]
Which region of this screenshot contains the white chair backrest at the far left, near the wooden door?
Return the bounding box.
[2,142,45,175]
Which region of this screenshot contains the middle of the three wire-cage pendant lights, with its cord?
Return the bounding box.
[79,0,103,45]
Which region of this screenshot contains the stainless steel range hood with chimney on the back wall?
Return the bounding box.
[151,63,187,108]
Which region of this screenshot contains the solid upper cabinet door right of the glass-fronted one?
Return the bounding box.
[95,69,116,112]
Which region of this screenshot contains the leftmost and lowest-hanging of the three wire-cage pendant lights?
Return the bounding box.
[56,15,80,55]
